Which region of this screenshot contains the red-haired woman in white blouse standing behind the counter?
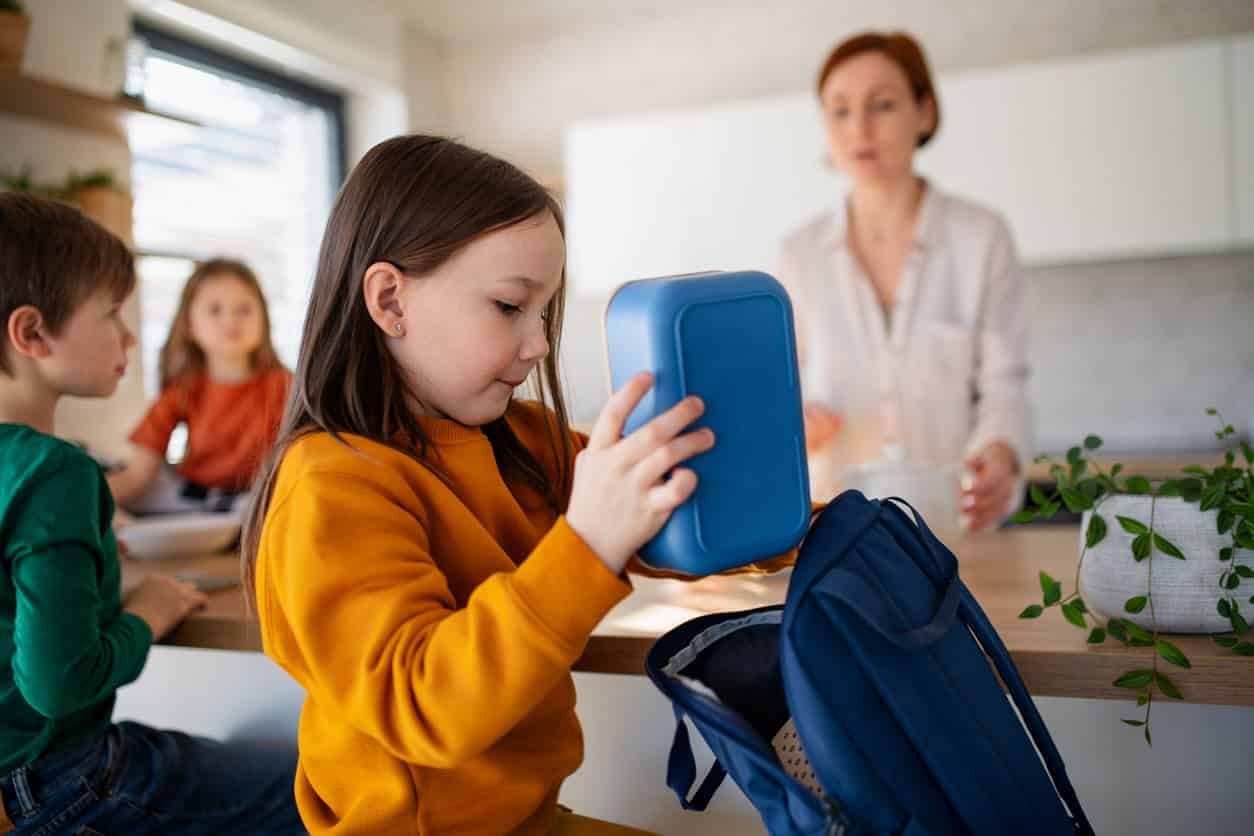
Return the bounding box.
[777,33,1032,529]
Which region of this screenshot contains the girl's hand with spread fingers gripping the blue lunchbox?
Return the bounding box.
[566,372,714,574]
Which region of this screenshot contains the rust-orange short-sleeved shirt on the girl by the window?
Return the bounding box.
[130,368,292,490]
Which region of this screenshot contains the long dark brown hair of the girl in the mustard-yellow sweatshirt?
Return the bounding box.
[241,134,571,605]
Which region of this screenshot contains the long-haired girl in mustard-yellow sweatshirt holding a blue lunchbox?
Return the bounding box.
[243,135,752,836]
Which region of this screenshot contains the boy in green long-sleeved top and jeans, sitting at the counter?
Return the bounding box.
[0,193,305,833]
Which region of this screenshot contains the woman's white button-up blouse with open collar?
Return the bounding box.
[777,185,1033,503]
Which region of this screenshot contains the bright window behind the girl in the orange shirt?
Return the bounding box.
[127,21,345,396]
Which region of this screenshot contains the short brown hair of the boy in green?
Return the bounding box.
[0,192,135,376]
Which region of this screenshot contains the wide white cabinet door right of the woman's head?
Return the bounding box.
[919,40,1230,262]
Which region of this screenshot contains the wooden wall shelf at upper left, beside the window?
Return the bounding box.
[0,70,199,142]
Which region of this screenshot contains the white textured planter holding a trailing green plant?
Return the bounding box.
[1080,495,1254,633]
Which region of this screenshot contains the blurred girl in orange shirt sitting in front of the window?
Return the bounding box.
[108,258,291,514]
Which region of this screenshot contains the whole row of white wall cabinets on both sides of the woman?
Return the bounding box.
[566,38,1254,292]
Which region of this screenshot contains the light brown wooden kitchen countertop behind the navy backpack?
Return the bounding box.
[137,525,1254,706]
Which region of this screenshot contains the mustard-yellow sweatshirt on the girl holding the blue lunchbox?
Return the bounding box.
[257,404,792,836]
